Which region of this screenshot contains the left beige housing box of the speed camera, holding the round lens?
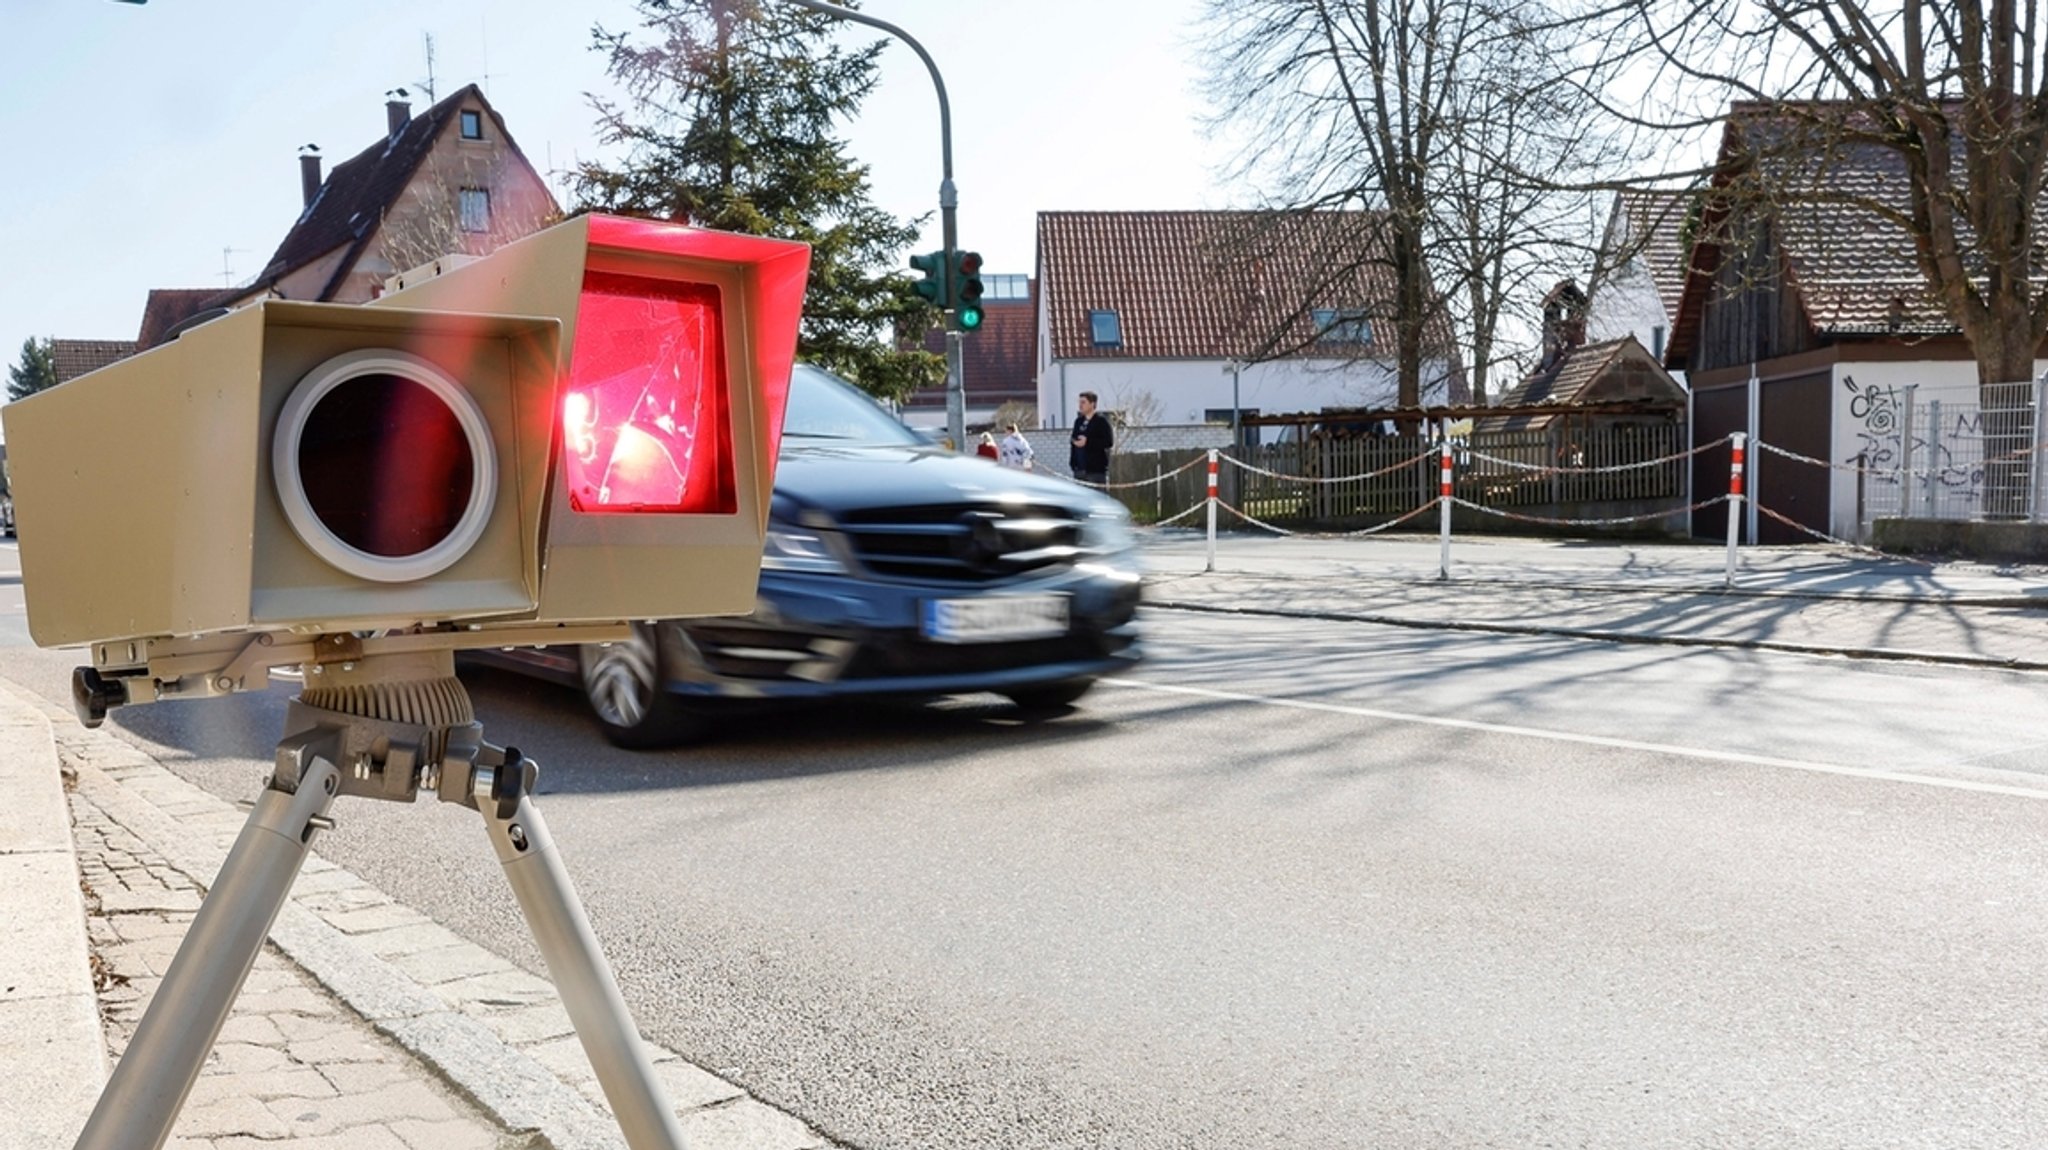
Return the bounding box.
[4,301,559,647]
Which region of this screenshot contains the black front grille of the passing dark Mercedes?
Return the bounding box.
[840,503,1081,583]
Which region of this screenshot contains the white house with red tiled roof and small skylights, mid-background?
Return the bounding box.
[1036,211,1468,428]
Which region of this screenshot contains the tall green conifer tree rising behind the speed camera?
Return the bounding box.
[573,0,944,397]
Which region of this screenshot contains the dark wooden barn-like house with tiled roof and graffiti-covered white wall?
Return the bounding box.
[1665,104,2048,542]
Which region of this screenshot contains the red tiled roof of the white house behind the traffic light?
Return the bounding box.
[1038,211,1452,360]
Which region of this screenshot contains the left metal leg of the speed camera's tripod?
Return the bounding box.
[76,757,340,1150]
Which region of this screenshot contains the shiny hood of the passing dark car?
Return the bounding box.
[774,444,1118,514]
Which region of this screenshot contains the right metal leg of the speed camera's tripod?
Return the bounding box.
[479,781,682,1150]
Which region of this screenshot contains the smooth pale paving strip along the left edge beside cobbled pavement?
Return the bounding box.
[0,692,106,1148]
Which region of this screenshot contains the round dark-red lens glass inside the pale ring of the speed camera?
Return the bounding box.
[299,372,475,559]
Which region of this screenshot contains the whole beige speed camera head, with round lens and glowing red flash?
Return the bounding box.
[4,215,809,654]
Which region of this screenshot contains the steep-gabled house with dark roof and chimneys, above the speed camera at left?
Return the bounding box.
[217,84,561,307]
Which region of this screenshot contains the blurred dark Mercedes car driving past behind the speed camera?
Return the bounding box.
[473,366,1139,747]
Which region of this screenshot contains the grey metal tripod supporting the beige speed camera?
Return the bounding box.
[76,651,682,1150]
